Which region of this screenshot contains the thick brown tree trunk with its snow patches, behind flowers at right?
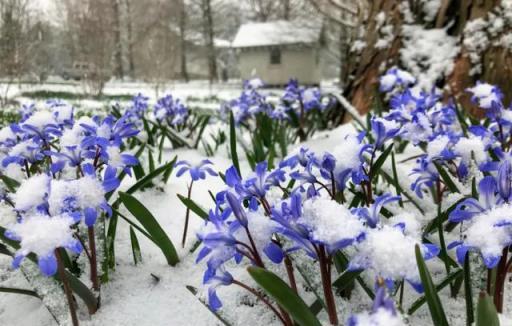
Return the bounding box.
[344,0,512,115]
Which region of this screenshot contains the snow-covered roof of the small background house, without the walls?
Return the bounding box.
[232,20,321,48]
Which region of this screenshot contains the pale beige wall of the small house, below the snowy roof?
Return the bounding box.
[238,46,321,85]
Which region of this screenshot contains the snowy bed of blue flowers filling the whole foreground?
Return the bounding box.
[0,74,512,326]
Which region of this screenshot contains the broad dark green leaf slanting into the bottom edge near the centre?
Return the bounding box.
[247,266,322,326]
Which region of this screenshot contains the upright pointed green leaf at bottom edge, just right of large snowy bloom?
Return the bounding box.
[415,245,449,326]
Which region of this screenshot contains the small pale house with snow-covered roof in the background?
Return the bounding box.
[232,21,322,85]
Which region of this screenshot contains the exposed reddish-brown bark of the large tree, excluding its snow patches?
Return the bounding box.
[344,0,512,116]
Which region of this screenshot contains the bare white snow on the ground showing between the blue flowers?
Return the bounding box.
[0,81,512,326]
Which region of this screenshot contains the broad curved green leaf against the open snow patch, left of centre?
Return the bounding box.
[119,192,179,266]
